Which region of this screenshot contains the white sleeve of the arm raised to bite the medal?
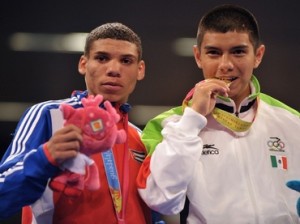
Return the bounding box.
[139,107,207,215]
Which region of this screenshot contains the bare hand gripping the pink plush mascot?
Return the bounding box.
[47,125,82,164]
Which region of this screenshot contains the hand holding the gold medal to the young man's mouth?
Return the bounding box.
[191,79,230,116]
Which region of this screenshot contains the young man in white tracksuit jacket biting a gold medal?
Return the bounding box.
[137,5,300,224]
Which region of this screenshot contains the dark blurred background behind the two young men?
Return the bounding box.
[0,0,300,223]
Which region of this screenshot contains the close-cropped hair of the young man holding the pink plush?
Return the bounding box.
[84,22,142,60]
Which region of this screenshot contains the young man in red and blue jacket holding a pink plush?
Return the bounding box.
[0,23,151,224]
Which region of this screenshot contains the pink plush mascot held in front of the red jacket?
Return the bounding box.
[50,95,126,197]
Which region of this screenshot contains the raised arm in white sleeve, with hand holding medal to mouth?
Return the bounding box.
[137,79,229,215]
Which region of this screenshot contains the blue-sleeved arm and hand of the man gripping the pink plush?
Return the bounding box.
[0,104,81,218]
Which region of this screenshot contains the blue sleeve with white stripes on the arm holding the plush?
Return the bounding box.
[0,104,59,219]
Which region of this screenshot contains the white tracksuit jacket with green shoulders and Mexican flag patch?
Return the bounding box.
[138,76,300,224]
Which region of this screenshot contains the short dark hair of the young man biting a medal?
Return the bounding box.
[197,4,260,49]
